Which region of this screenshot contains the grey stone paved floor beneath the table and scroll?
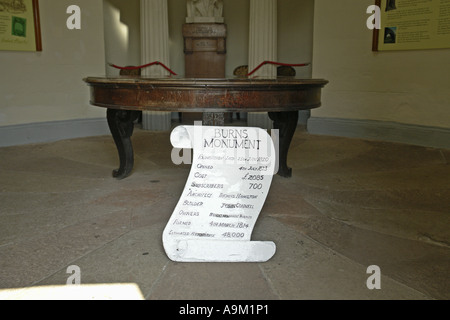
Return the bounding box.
[0,128,450,300]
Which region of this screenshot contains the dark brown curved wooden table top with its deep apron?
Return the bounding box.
[83,76,328,112]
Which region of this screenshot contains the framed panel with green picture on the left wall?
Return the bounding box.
[0,0,42,51]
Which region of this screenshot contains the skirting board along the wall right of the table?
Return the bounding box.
[307,117,450,149]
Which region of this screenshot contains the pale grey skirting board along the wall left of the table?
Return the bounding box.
[0,117,110,147]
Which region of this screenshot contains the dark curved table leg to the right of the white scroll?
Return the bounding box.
[269,111,298,178]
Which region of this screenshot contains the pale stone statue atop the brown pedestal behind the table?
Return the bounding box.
[186,0,224,23]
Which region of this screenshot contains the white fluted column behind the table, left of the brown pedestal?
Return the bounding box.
[141,0,172,131]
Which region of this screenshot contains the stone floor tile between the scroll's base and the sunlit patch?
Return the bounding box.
[35,224,169,295]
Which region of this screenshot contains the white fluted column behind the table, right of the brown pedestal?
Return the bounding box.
[247,0,277,129]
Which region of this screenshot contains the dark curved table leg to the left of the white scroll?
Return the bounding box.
[106,109,139,180]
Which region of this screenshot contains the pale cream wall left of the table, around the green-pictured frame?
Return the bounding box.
[0,0,105,126]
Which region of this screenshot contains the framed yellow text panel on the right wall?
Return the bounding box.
[373,0,450,51]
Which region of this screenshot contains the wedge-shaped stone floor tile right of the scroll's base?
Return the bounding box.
[261,221,429,300]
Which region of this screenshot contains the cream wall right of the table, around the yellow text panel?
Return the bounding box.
[312,0,450,128]
